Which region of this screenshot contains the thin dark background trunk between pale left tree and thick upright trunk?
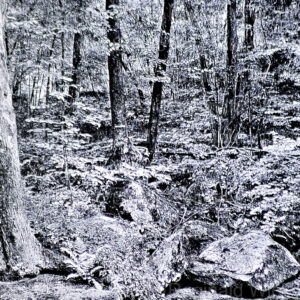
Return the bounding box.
[69,0,83,103]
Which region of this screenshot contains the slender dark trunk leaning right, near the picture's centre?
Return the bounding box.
[147,0,174,161]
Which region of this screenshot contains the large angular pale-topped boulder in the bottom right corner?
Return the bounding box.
[187,231,300,292]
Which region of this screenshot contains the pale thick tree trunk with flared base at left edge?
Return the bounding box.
[0,0,43,276]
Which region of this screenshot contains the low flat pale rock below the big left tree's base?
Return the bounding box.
[0,275,122,300]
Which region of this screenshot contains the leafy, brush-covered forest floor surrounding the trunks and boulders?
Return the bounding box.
[0,92,300,300]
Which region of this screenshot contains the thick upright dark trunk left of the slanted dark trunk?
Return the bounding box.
[106,0,127,163]
